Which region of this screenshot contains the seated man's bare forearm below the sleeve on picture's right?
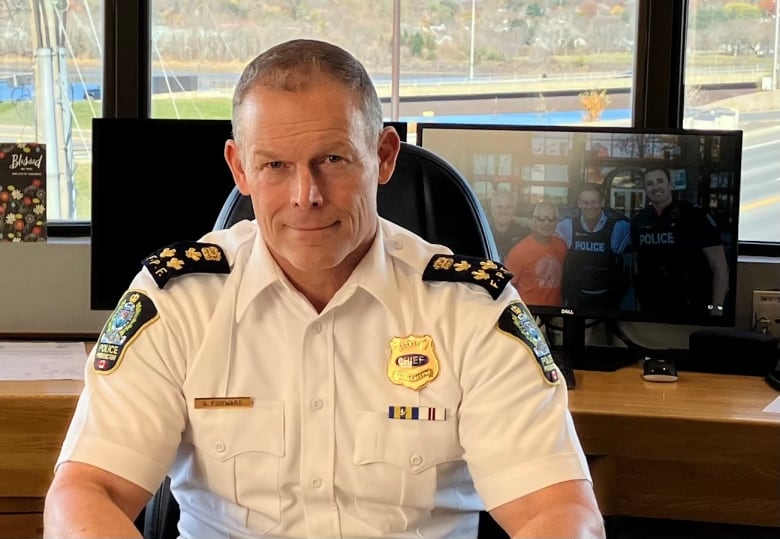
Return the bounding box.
[490,479,606,539]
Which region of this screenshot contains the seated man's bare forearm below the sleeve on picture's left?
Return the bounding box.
[43,485,141,539]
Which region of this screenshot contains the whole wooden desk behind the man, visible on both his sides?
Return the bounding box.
[0,356,780,539]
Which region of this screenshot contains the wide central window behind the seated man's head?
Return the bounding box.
[150,0,636,126]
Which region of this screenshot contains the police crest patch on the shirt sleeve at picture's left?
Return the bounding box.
[92,290,159,374]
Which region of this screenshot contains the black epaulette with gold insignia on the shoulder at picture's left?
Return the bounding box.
[142,241,230,288]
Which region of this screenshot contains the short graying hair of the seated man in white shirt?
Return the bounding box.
[232,39,383,146]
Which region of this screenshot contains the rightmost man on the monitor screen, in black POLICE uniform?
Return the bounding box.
[631,169,729,316]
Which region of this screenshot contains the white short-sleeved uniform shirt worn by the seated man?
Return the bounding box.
[58,220,590,539]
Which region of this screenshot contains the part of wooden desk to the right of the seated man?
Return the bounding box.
[569,366,780,527]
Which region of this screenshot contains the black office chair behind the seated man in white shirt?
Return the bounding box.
[136,142,506,539]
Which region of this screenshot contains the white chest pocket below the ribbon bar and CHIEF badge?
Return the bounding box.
[353,412,463,533]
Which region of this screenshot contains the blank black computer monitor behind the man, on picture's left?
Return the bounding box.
[90,118,406,310]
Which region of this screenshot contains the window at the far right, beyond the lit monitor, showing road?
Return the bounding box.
[683,0,780,246]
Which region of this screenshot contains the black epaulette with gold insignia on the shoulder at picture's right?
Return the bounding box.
[423,254,512,299]
